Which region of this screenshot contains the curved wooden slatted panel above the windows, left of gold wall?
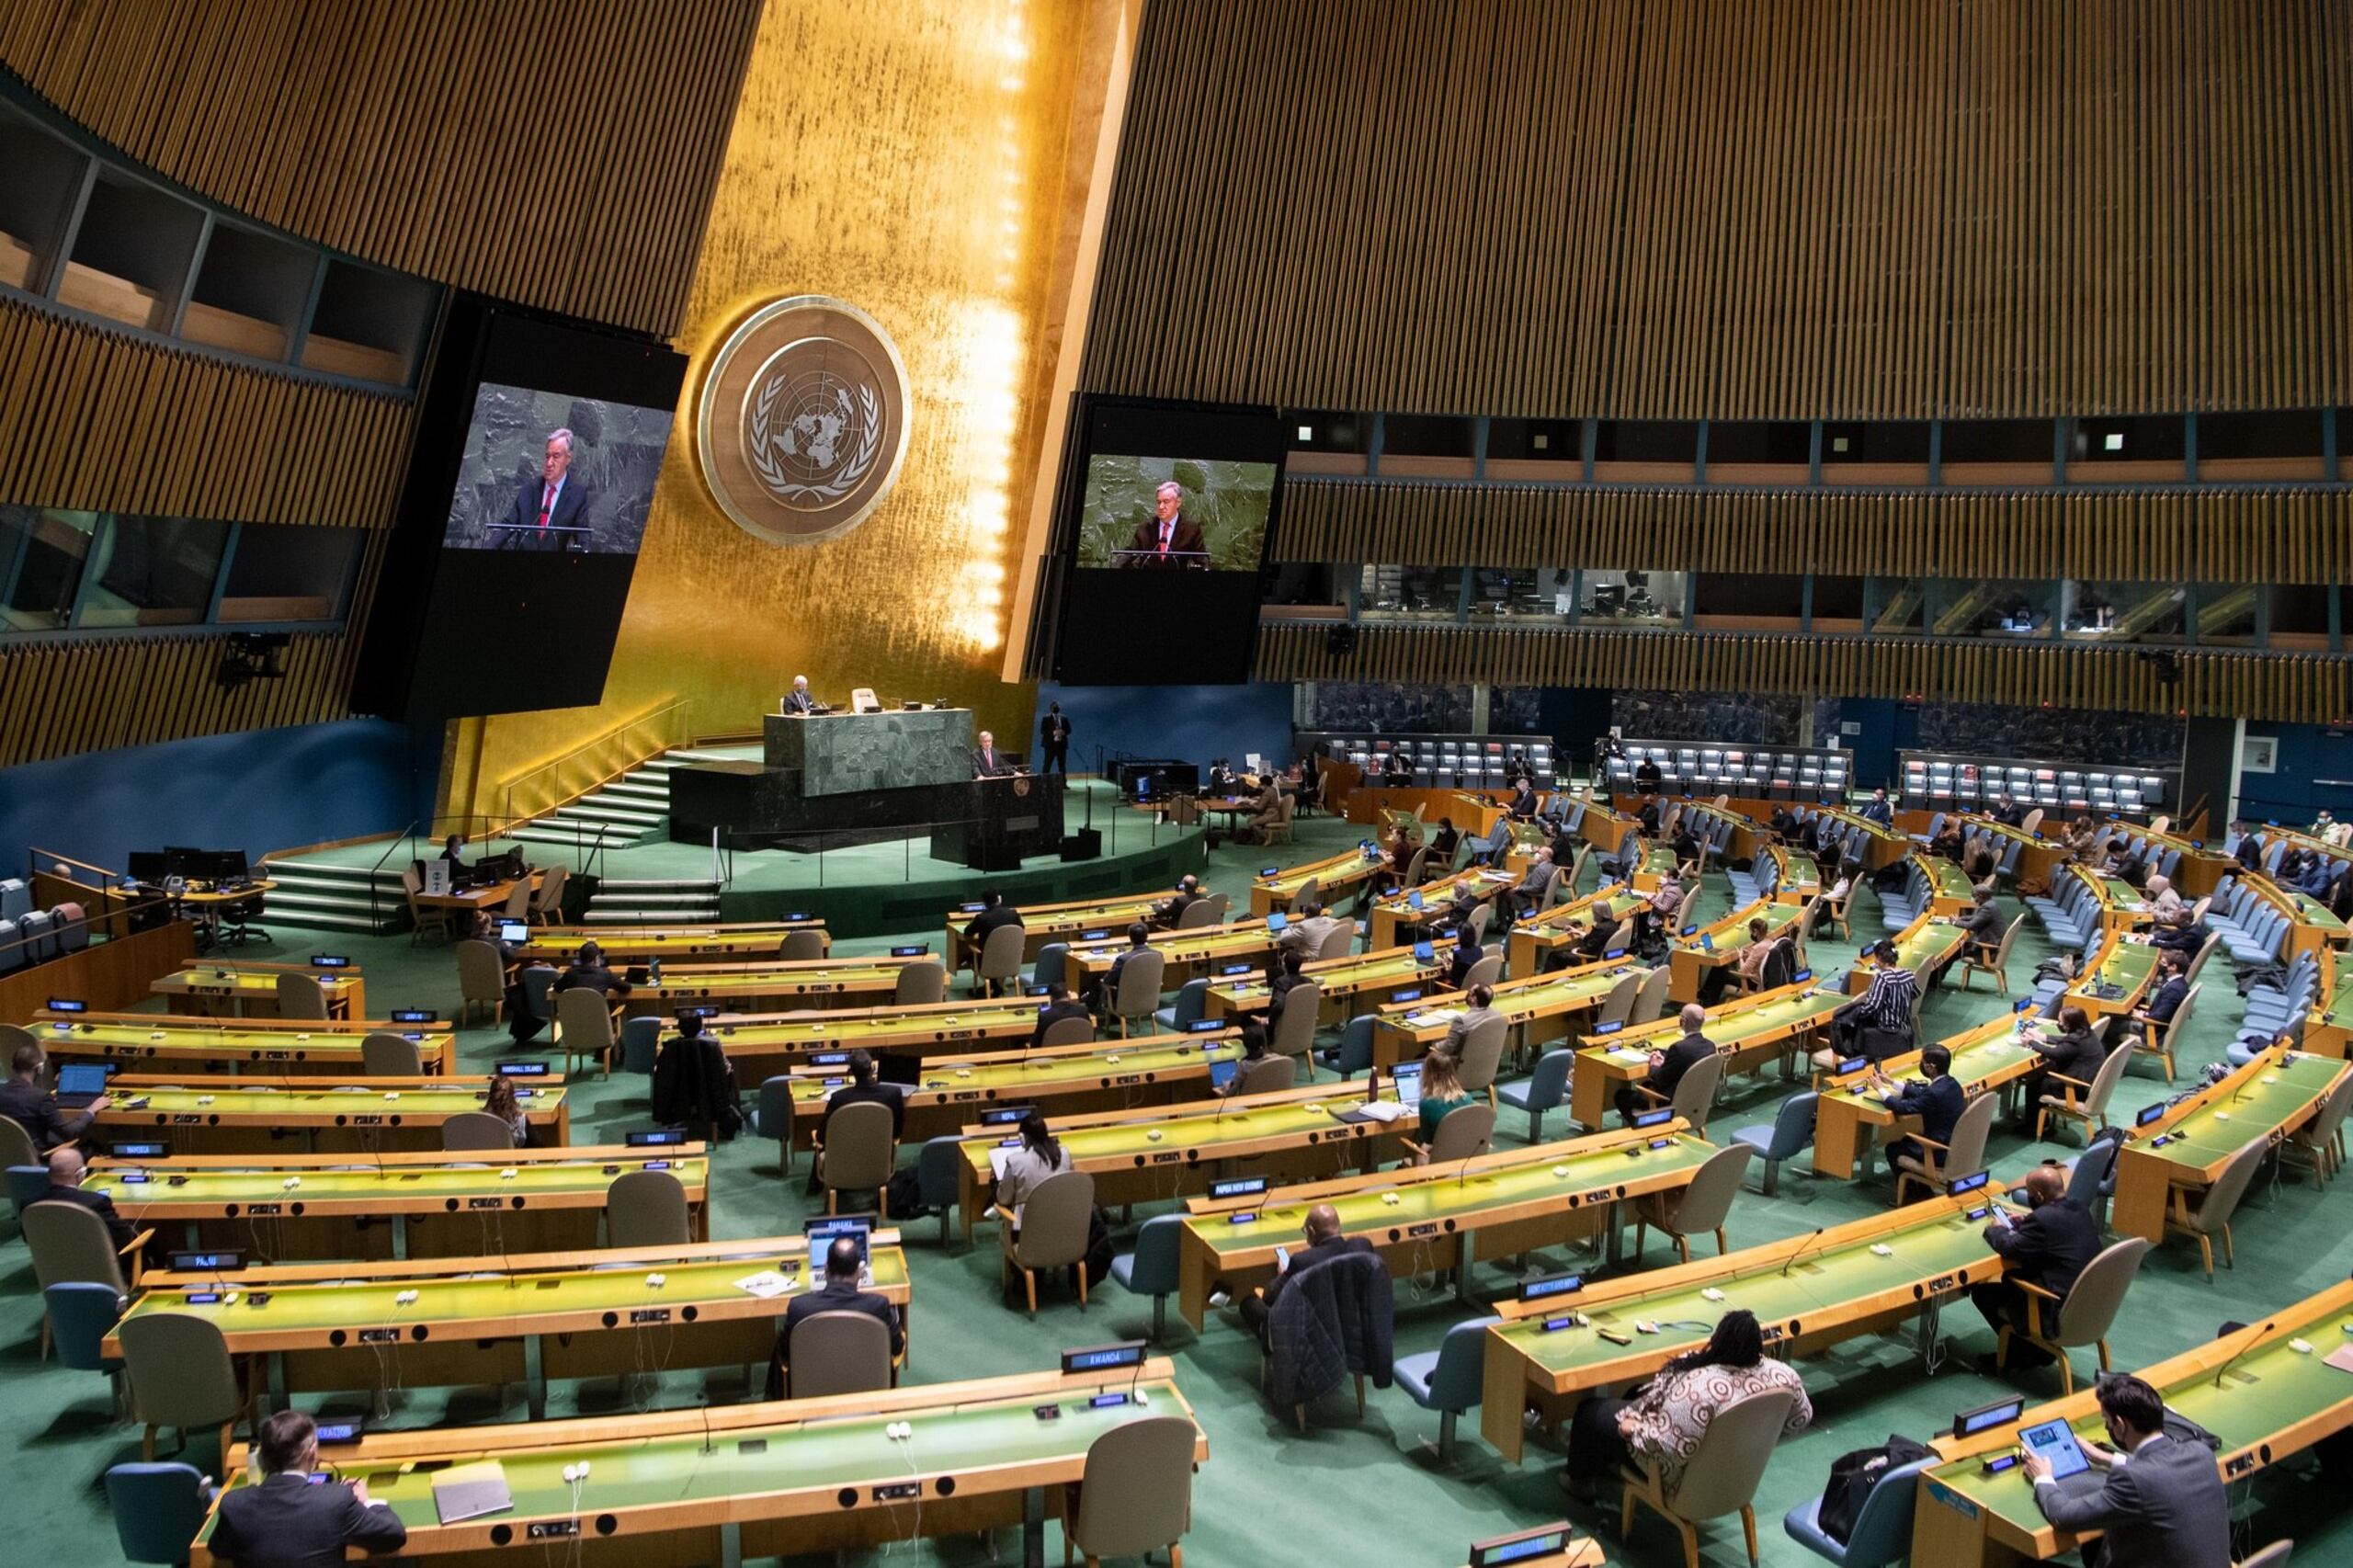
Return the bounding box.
[0,0,757,336]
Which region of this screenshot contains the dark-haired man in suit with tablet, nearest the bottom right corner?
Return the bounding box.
[2026,1378,2231,1568]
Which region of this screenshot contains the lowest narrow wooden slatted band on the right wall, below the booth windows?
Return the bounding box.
[1256,626,2353,722]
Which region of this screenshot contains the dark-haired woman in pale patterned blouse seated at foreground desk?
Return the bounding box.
[1560,1312,1814,1493]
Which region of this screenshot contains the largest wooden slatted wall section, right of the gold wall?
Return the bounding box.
[1083,0,2353,419]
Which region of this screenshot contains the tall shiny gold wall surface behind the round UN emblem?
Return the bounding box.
[463,0,1110,812]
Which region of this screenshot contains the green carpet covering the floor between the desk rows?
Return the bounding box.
[0,819,2353,1568]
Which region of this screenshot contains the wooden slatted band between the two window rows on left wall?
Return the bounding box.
[0,299,415,528]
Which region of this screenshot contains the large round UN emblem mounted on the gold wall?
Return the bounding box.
[697,294,908,544]
